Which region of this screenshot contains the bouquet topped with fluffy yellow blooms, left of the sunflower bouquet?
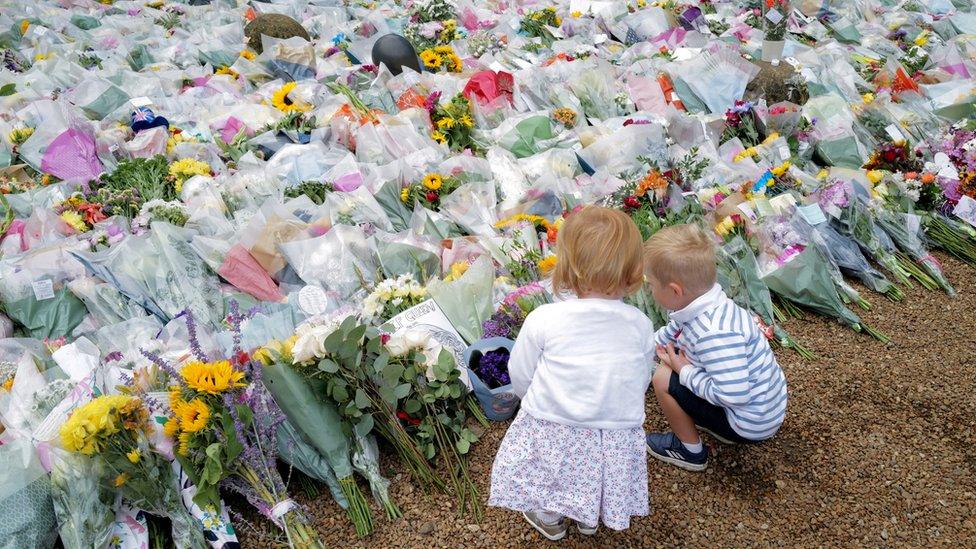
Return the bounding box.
[61,395,205,547]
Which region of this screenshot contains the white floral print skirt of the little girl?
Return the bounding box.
[488,411,649,530]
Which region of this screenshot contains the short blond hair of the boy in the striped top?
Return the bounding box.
[644,225,716,293]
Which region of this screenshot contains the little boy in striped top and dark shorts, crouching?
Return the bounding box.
[644,225,786,471]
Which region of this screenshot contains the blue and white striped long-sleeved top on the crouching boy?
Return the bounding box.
[654,284,786,440]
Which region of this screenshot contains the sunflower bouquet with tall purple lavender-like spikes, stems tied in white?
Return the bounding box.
[143,310,321,548]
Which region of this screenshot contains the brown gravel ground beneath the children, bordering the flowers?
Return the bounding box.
[234,255,976,547]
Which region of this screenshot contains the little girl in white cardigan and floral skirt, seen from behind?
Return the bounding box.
[488,207,654,541]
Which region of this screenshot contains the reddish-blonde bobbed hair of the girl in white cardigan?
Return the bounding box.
[552,206,644,296]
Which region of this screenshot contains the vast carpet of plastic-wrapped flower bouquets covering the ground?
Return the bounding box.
[0,0,976,548]
